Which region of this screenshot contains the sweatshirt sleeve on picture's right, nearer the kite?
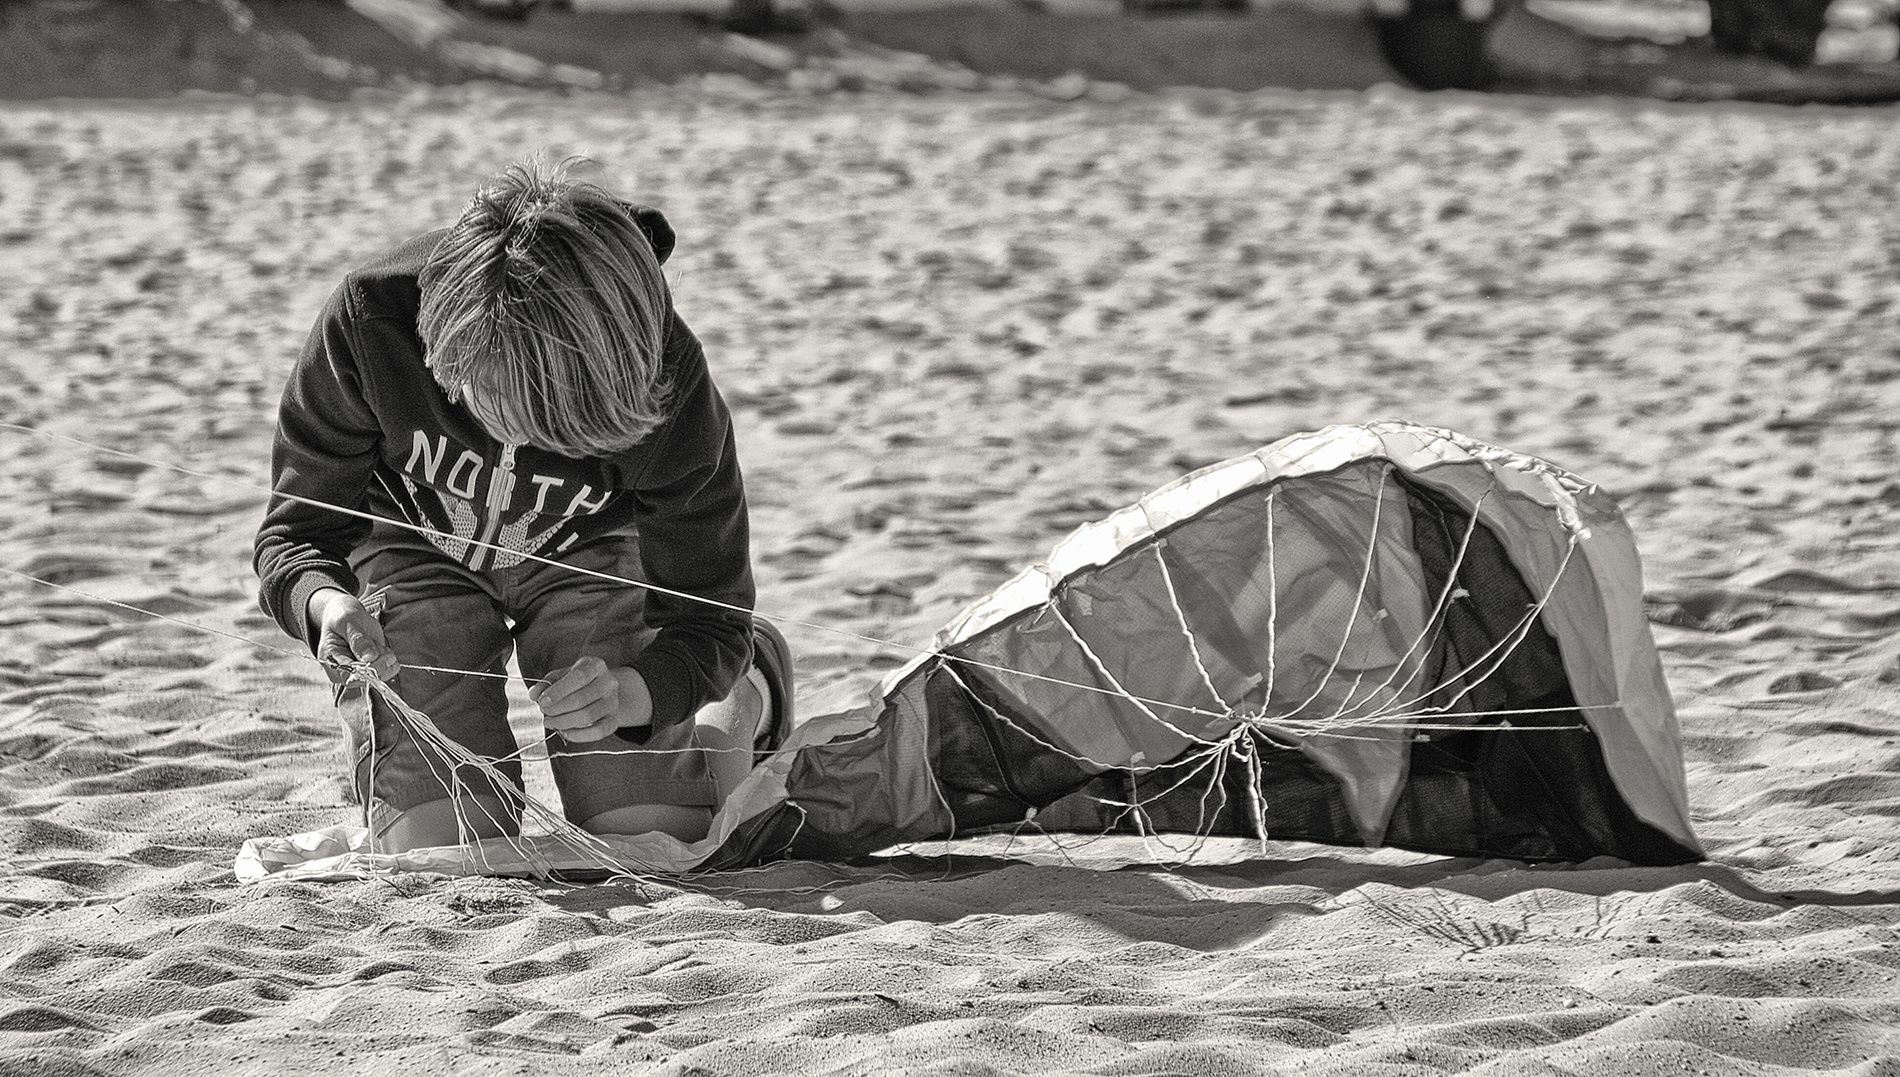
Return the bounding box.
[621,327,754,741]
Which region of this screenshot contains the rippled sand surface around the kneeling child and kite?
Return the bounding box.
[0,78,1900,1077]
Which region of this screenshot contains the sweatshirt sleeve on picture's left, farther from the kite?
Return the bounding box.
[253,283,382,642]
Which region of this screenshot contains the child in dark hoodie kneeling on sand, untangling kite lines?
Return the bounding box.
[255,160,783,851]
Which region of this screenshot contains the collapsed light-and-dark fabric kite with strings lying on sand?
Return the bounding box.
[236,422,1701,881]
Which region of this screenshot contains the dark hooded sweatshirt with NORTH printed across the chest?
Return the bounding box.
[253,207,752,741]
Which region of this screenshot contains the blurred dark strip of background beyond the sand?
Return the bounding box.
[0,0,1900,103]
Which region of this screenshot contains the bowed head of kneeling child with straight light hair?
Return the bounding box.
[416,158,669,456]
